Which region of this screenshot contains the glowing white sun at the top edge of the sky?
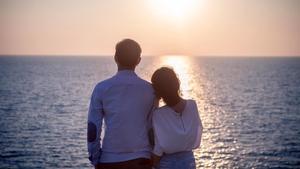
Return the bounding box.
[149,0,199,20]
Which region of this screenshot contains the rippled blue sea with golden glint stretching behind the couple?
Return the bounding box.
[0,56,300,169]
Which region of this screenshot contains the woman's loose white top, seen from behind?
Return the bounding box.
[152,100,202,156]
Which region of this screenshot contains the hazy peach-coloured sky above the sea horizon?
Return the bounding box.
[0,0,300,56]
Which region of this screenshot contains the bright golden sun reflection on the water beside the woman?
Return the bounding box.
[155,55,223,168]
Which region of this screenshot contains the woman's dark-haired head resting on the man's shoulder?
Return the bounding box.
[151,67,180,106]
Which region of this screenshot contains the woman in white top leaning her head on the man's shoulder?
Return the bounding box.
[151,67,202,169]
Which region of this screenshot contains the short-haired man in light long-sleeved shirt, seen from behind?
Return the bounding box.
[87,39,155,169]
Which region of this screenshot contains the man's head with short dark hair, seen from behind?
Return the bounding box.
[115,39,142,70]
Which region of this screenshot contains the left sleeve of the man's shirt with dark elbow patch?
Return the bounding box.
[87,85,103,166]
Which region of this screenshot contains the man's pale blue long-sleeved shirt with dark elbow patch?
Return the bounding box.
[88,70,154,164]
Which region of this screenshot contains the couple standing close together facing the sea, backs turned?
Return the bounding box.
[87,39,202,169]
